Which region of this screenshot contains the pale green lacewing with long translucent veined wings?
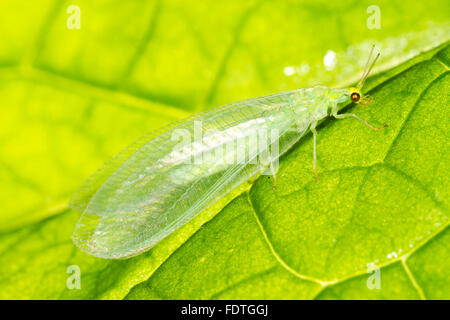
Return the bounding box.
[71,47,387,258]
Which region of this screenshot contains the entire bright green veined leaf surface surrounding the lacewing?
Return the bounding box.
[0,0,450,299]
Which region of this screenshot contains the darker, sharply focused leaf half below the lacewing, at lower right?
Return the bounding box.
[124,46,450,299]
